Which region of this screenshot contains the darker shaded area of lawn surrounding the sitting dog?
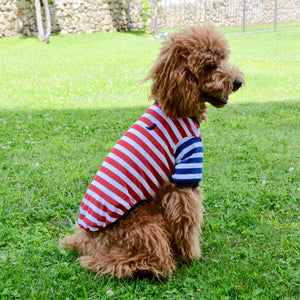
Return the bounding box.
[0,101,300,299]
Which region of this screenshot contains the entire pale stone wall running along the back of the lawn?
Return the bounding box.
[0,0,300,37]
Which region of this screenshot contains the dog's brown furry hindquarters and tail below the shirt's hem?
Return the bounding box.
[62,201,175,278]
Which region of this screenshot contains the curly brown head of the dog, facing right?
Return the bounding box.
[147,27,244,121]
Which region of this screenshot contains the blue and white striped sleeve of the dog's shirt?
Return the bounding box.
[171,137,203,187]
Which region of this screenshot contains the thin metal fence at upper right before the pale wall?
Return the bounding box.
[149,0,300,34]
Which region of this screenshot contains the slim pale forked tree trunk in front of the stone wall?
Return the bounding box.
[35,0,51,44]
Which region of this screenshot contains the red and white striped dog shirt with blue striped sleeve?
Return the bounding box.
[78,104,203,231]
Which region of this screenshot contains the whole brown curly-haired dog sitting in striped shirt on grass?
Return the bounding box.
[62,27,244,278]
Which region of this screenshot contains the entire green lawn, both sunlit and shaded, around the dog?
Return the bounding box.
[0,30,300,299]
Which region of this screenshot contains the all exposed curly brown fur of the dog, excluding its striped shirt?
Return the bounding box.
[62,27,244,278]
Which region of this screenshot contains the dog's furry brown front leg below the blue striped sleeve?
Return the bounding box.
[161,183,203,261]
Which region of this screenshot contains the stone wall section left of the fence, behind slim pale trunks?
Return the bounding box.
[0,0,143,37]
